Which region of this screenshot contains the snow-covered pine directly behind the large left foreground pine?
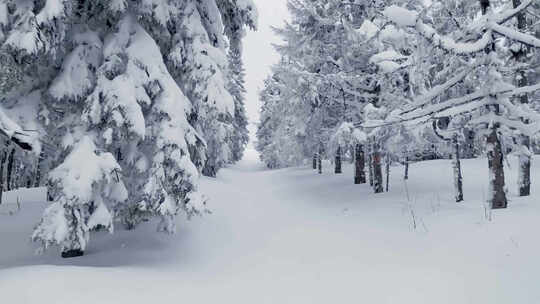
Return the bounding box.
[168,0,257,176]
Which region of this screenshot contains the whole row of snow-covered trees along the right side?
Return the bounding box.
[256,0,540,209]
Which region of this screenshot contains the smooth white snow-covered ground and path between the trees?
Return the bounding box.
[0,152,540,304]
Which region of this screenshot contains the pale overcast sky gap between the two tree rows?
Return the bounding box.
[243,0,289,131]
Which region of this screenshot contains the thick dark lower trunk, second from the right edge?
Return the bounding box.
[487,124,508,209]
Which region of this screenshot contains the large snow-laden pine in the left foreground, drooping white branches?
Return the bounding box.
[0,0,255,256]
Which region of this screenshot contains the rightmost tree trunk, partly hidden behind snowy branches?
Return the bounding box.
[512,0,531,196]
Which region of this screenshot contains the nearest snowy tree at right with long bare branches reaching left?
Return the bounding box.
[376,1,540,208]
